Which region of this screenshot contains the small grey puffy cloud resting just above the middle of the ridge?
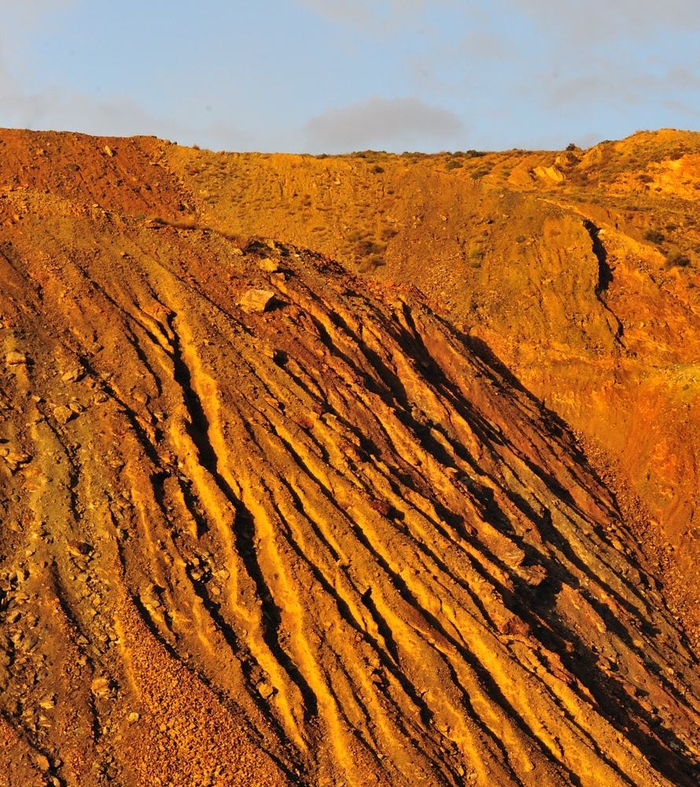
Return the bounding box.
[305,96,464,152]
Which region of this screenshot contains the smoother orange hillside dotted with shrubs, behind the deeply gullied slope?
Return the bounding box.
[164,130,700,625]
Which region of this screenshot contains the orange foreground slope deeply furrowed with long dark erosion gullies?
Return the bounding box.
[0,180,700,787]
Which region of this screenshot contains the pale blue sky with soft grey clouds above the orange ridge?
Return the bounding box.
[0,0,700,153]
